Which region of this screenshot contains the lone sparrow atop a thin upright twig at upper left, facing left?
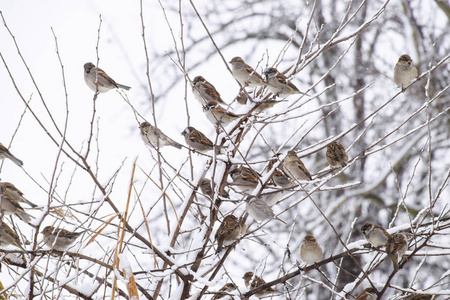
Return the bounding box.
[84,62,131,93]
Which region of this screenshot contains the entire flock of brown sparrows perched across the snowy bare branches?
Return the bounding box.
[0,54,420,300]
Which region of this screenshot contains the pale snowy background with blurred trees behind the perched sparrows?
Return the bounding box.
[0,0,450,299]
